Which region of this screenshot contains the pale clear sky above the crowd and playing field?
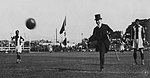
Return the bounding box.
[0,0,150,42]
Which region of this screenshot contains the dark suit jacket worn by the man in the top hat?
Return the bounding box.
[89,24,113,52]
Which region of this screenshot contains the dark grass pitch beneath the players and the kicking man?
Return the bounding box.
[0,51,150,78]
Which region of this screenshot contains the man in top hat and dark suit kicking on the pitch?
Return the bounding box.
[89,14,113,71]
